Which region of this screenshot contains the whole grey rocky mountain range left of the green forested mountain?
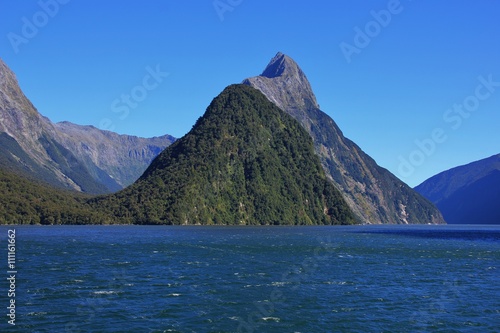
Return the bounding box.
[0,60,174,194]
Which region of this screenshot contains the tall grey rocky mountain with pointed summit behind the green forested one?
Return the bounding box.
[243,53,445,224]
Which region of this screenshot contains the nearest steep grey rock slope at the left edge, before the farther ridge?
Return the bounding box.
[0,60,107,193]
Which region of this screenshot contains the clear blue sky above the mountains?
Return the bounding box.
[0,0,500,186]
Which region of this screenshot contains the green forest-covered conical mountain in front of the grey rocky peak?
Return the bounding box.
[90,85,356,225]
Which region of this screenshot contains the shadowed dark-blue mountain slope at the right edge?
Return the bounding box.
[415,154,500,224]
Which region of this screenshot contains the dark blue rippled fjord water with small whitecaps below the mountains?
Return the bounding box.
[0,226,500,332]
